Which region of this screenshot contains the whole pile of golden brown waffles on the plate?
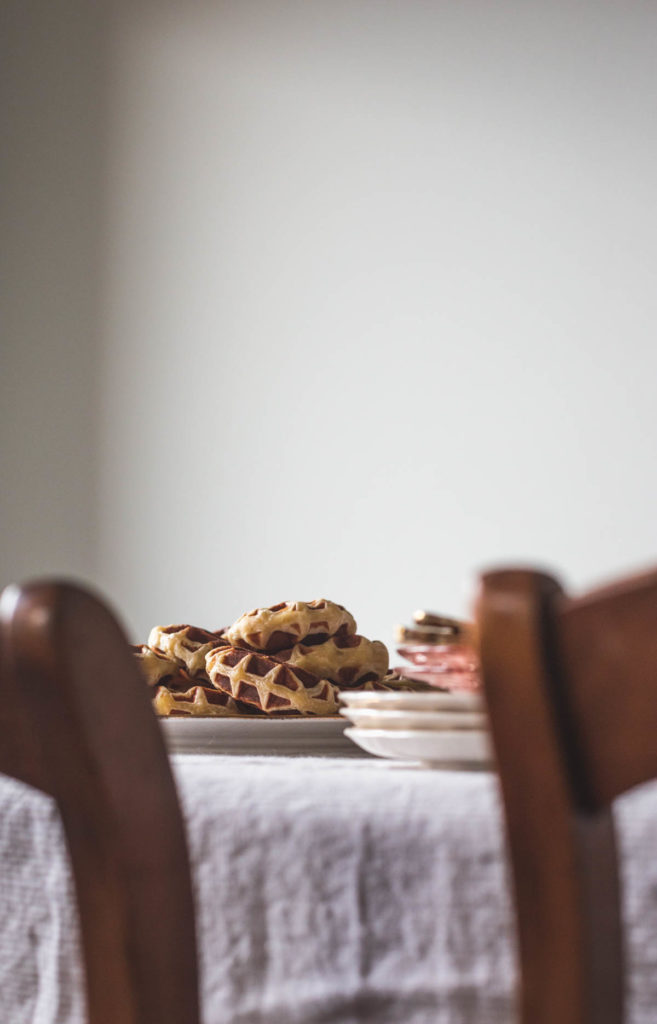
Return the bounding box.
[134,599,425,717]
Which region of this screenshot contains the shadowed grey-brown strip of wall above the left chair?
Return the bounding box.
[0,0,102,587]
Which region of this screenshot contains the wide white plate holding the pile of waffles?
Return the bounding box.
[160,716,362,758]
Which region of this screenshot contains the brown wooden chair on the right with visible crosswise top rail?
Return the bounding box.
[477,570,657,1024]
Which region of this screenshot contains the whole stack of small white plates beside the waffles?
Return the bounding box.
[340,690,491,768]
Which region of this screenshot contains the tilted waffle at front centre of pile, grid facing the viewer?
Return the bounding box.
[206,647,338,715]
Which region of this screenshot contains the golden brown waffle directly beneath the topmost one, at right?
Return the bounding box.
[275,633,388,689]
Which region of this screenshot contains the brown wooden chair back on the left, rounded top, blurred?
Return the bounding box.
[0,583,199,1024]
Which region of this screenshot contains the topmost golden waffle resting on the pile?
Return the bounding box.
[225,599,356,654]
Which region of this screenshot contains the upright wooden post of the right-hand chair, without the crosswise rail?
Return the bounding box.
[478,570,623,1024]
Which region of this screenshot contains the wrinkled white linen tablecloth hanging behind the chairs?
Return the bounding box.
[0,757,657,1024]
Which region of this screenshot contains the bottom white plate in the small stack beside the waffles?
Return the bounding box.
[345,727,491,768]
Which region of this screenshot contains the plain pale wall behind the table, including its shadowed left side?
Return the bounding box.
[0,0,657,641]
